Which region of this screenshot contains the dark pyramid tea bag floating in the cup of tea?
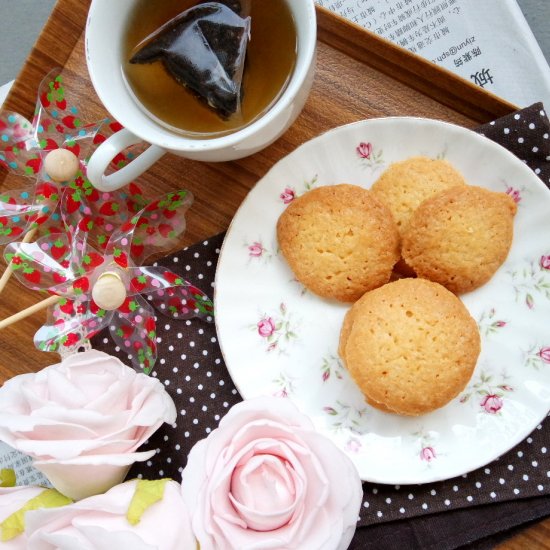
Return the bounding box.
[130,0,251,119]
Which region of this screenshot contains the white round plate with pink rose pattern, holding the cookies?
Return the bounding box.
[215,118,550,484]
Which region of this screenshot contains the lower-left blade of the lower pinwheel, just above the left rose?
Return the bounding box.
[34,298,113,352]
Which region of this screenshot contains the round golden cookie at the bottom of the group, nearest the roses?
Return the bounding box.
[340,279,480,416]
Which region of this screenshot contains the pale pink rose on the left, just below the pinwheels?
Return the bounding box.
[0,350,176,499]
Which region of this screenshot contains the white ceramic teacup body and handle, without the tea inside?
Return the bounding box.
[86,0,317,191]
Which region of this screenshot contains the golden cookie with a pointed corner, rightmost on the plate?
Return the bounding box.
[401,186,516,294]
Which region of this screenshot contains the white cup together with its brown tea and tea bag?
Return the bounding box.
[86,0,316,191]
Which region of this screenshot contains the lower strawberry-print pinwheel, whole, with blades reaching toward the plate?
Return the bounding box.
[5,191,213,373]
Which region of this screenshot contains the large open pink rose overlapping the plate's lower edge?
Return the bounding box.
[181,397,363,550]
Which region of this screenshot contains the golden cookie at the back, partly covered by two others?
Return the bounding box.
[371,157,466,239]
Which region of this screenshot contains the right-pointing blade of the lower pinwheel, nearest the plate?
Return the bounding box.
[126,266,214,320]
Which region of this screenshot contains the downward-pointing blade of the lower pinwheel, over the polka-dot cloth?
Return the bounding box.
[109,295,157,374]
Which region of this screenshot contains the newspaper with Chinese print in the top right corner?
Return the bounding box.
[316,0,550,108]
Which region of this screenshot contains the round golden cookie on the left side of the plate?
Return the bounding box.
[277,184,399,302]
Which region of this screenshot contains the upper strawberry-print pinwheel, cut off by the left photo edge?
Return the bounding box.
[0,72,103,244]
